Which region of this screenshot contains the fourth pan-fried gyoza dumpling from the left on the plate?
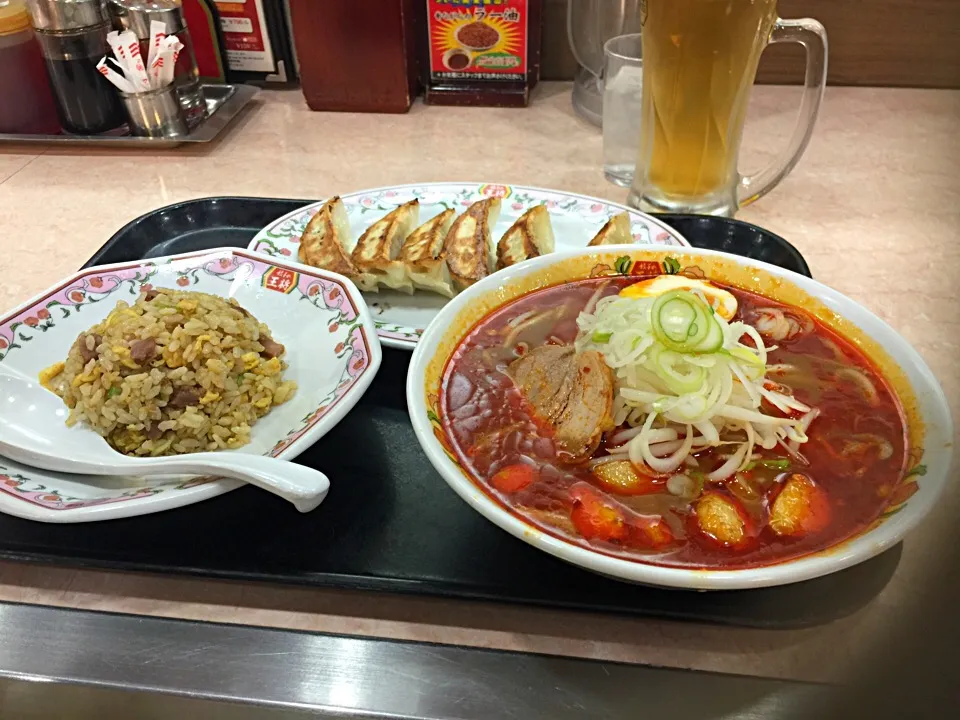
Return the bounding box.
[443,198,500,290]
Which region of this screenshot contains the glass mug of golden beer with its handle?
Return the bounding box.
[628,0,827,217]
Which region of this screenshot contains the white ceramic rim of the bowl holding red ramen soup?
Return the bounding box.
[407,246,953,590]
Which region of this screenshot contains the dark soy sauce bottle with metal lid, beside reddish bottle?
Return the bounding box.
[29,0,126,135]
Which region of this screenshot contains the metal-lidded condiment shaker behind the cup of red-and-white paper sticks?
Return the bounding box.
[107,0,207,127]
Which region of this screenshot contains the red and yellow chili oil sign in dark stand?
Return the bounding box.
[424,0,544,107]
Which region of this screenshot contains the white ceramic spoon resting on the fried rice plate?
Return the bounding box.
[0,370,330,512]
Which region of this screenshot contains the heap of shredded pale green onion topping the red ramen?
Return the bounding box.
[575,289,811,482]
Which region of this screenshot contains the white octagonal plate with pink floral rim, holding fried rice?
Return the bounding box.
[0,248,381,523]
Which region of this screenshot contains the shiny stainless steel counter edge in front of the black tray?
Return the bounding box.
[0,603,823,720]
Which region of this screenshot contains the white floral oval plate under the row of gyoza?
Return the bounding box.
[248,182,690,350]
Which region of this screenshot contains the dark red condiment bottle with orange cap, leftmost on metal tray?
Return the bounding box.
[0,0,60,135]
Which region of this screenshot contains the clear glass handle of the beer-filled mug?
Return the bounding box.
[737,18,827,207]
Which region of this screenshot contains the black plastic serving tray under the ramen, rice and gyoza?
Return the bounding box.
[0,198,900,627]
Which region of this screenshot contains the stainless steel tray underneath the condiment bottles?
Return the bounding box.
[0,84,260,148]
